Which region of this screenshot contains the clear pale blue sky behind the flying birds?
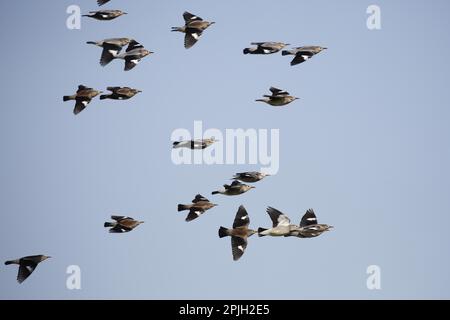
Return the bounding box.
[0,0,450,299]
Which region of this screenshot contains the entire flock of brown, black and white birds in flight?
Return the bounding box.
[5,0,333,283]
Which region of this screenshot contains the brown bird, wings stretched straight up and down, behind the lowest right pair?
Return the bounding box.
[219,205,257,261]
